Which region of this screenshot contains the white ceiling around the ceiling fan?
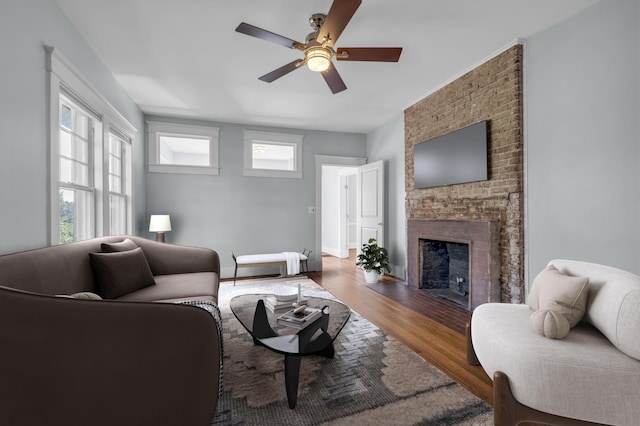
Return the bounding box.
[56,0,596,133]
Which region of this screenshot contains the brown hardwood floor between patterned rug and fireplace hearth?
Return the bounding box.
[307,251,493,405]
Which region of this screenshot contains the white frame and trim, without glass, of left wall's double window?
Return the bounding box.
[45,46,137,245]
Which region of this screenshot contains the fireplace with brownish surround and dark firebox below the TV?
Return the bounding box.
[407,219,500,310]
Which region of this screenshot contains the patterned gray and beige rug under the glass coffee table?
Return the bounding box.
[211,277,493,426]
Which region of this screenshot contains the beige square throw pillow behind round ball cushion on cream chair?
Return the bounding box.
[529,265,589,327]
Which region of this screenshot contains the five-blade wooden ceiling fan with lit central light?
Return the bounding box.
[236,0,402,94]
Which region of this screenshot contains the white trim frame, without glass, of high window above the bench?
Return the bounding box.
[243,130,304,179]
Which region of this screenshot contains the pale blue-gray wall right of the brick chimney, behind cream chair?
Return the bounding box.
[525,0,640,283]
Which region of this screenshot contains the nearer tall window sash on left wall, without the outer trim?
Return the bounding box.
[59,95,95,243]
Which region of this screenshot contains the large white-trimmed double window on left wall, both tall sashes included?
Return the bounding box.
[47,47,136,244]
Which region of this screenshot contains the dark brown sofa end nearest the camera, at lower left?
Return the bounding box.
[0,287,220,425]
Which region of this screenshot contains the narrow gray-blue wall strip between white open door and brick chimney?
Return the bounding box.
[367,112,407,279]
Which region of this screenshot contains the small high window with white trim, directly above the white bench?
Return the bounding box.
[244,130,304,179]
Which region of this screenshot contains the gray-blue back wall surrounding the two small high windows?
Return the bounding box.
[143,116,366,278]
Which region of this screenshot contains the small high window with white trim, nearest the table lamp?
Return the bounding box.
[147,121,220,175]
